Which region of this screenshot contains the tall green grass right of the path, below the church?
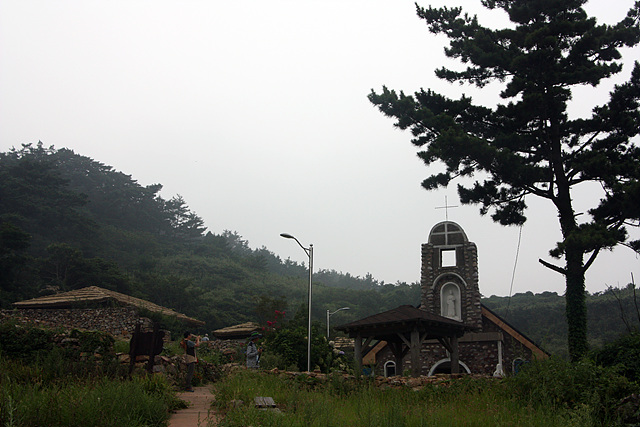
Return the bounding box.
[216,371,575,427]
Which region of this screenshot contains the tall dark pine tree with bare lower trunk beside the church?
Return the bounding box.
[369,0,640,359]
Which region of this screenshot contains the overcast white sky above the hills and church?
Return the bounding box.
[0,0,640,296]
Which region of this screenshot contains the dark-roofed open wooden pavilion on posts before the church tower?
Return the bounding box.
[336,305,470,377]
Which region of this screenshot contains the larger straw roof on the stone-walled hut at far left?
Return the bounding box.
[13,286,204,325]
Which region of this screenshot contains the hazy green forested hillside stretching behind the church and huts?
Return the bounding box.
[0,142,639,356]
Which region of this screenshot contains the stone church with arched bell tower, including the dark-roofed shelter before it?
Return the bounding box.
[337,221,548,376]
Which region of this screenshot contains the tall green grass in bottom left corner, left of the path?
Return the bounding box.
[0,351,183,427]
